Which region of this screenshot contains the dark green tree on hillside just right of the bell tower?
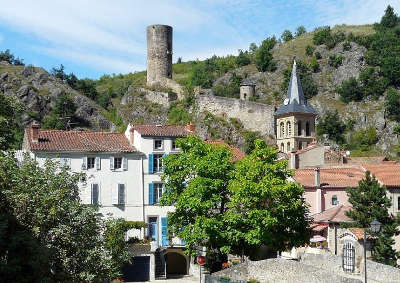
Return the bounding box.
[317,110,346,144]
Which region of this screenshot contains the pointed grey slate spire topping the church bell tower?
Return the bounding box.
[275,60,318,115]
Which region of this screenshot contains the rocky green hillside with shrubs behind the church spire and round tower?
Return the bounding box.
[0,6,400,157]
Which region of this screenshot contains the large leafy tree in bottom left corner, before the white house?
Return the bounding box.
[0,154,138,282]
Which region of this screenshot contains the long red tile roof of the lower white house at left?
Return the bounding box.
[25,129,136,152]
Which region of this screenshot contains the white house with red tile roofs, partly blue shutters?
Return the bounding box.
[22,124,194,278]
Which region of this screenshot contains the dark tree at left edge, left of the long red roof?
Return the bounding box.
[0,93,23,150]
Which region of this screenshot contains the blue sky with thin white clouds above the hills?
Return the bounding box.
[0,0,400,79]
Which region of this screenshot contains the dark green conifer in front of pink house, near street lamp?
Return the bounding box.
[346,171,399,266]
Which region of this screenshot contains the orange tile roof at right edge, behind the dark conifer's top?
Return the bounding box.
[362,163,400,187]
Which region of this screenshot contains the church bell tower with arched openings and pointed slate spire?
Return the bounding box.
[275,61,317,153]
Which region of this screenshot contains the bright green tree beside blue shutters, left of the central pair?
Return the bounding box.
[160,136,234,266]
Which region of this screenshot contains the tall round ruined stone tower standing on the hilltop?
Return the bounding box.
[146,25,172,85]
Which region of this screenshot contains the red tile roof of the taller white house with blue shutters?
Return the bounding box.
[131,125,192,137]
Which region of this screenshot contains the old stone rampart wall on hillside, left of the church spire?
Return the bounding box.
[196,95,275,135]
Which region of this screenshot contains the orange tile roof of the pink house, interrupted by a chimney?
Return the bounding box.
[294,167,365,188]
